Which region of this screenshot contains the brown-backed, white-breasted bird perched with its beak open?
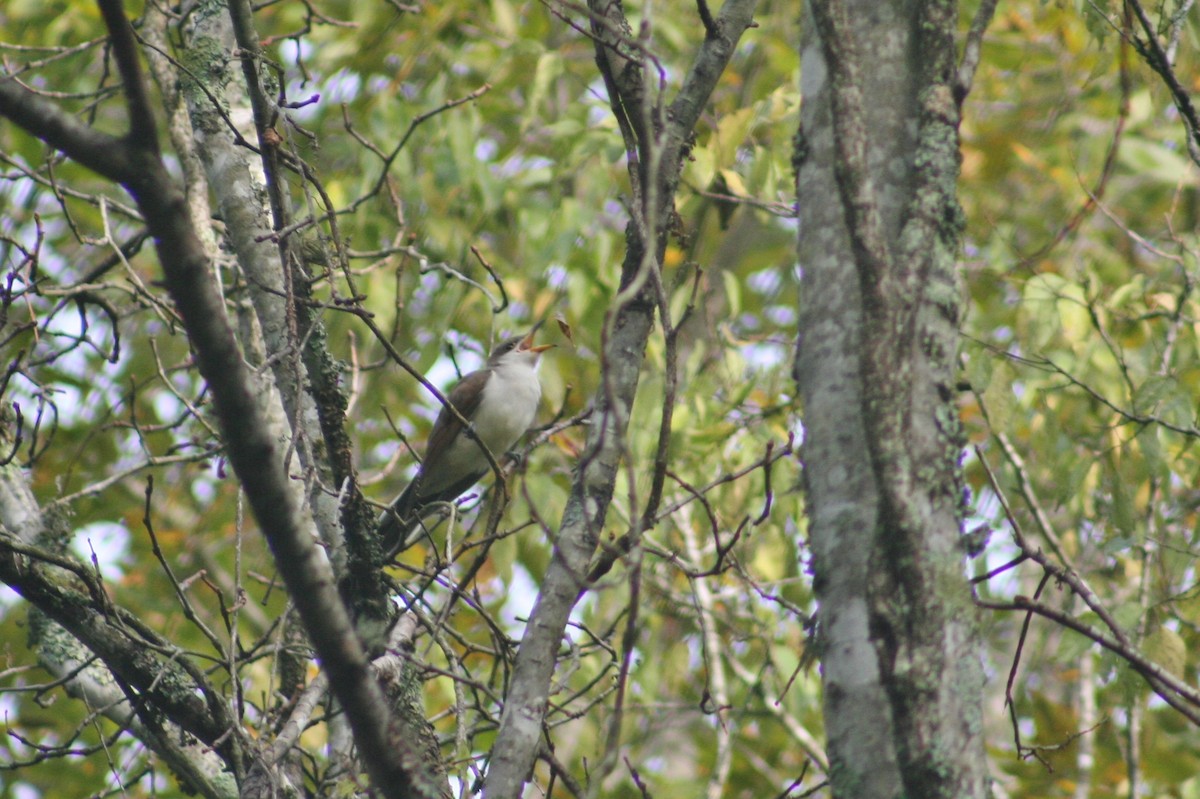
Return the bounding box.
[378,328,553,559]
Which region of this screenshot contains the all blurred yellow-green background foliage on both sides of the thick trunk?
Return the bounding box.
[0,0,1200,799]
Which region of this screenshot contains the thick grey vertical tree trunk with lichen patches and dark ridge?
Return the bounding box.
[796,0,986,799]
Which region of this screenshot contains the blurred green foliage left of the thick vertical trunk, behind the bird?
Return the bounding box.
[2,2,806,797]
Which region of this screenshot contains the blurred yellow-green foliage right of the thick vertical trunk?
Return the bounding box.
[962,4,1200,797]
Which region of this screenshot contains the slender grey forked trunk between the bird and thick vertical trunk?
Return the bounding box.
[484,0,756,799]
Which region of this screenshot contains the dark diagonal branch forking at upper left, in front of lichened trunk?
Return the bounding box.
[0,0,436,799]
